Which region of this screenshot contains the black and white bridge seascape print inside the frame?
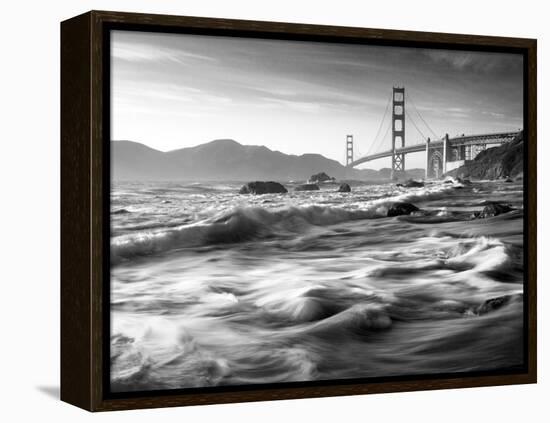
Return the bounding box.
[107,30,526,393]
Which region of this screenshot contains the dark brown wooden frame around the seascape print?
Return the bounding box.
[61,11,537,411]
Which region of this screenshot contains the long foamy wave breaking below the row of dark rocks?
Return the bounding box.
[111,186,462,264]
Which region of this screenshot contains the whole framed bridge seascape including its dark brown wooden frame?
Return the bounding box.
[61,11,536,411]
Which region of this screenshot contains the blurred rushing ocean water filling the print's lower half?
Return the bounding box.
[111,181,524,392]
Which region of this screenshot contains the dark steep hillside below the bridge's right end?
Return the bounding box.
[447,132,523,179]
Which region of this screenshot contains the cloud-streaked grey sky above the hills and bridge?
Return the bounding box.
[111,31,523,169]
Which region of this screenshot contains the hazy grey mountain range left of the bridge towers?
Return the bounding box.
[111,139,426,181]
